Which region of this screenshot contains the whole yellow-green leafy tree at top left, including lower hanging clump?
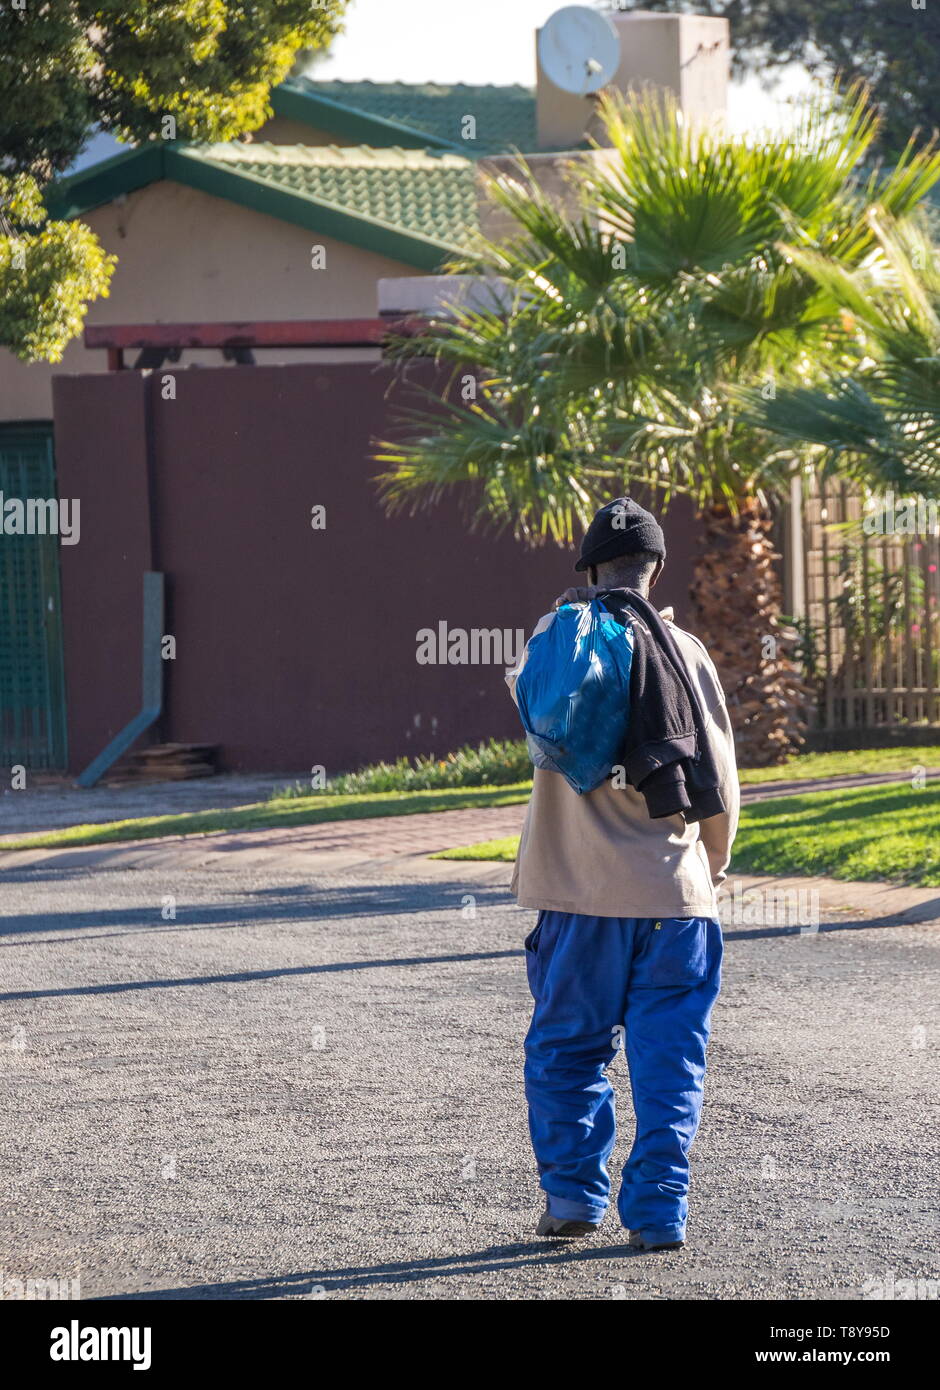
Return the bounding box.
[0,0,346,361]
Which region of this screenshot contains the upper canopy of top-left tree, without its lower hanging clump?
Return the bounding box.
[0,0,346,178]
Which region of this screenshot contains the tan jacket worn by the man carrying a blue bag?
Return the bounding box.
[506,609,740,917]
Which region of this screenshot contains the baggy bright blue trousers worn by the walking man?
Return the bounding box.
[526,912,722,1243]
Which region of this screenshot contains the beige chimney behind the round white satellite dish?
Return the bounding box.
[535,10,730,150]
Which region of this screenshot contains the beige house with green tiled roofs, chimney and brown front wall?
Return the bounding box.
[0,13,727,771]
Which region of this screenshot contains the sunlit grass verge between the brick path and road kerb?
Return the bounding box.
[432,783,940,888]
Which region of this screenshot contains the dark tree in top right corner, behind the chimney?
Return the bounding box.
[616,0,940,150]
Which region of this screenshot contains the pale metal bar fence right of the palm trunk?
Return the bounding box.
[790,477,940,731]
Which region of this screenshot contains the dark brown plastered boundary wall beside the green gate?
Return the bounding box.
[56,364,694,774]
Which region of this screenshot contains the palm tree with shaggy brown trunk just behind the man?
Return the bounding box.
[377,90,940,765]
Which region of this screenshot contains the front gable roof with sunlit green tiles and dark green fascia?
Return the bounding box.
[47,140,478,270]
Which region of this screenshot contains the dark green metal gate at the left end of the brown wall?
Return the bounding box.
[0,424,67,783]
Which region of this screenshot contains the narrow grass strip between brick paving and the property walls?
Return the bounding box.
[0,746,940,859]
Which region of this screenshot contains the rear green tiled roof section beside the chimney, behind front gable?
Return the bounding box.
[271,78,537,156]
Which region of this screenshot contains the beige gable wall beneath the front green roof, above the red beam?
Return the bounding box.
[0,181,419,420]
